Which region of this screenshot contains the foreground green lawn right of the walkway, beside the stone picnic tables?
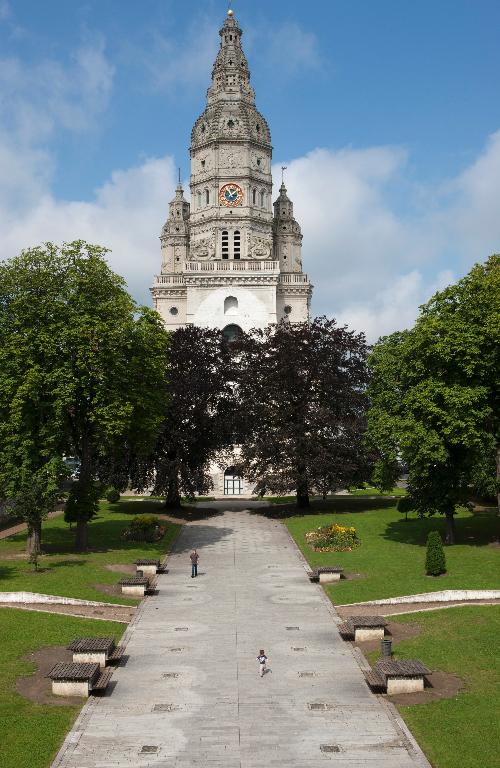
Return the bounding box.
[370,605,500,768]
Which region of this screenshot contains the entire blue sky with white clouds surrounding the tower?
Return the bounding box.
[0,0,500,338]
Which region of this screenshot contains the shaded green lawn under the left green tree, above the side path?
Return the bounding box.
[0,500,180,604]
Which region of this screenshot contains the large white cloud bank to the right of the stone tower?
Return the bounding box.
[274,131,500,340]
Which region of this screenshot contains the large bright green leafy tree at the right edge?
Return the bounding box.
[369,256,500,543]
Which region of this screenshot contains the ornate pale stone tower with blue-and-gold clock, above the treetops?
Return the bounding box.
[151,10,312,336]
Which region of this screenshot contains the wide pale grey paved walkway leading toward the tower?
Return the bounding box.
[54,510,428,768]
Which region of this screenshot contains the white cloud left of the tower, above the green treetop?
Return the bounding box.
[0,151,175,302]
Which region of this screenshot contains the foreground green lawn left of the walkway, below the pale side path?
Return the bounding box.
[0,608,125,768]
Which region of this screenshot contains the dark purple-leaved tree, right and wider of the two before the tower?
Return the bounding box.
[238,318,368,507]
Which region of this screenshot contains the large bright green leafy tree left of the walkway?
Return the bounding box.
[0,241,167,549]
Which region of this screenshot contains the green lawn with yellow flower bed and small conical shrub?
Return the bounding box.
[285,504,500,604]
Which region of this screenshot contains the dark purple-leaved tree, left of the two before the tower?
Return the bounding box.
[135,326,239,508]
